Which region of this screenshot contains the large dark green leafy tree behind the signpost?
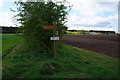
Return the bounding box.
[15,0,70,51]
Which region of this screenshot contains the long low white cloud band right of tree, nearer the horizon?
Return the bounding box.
[68,13,118,27]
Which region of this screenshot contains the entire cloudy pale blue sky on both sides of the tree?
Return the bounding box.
[0,0,119,33]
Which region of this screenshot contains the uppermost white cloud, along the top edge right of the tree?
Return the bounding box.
[69,0,118,16]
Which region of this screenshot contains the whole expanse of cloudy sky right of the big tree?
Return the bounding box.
[67,0,118,30]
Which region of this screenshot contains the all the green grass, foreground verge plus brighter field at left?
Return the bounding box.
[2,34,119,78]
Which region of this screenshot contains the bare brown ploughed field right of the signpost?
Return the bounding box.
[62,34,118,57]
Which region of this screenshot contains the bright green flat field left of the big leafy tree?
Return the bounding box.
[2,34,20,56]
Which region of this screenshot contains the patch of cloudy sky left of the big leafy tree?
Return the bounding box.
[0,0,20,27]
